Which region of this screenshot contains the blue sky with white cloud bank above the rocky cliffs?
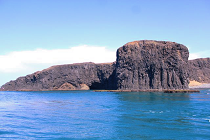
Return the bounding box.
[0,0,210,86]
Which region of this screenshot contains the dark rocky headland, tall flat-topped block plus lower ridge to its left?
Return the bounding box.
[1,40,189,91]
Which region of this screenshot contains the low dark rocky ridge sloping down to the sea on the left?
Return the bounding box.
[2,63,116,91]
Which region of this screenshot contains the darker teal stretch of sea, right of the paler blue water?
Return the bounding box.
[117,90,210,139]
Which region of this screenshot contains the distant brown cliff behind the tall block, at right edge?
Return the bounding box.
[189,58,210,83]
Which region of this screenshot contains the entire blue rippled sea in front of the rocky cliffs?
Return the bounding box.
[0,89,210,140]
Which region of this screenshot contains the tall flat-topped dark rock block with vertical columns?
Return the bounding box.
[116,40,189,89]
